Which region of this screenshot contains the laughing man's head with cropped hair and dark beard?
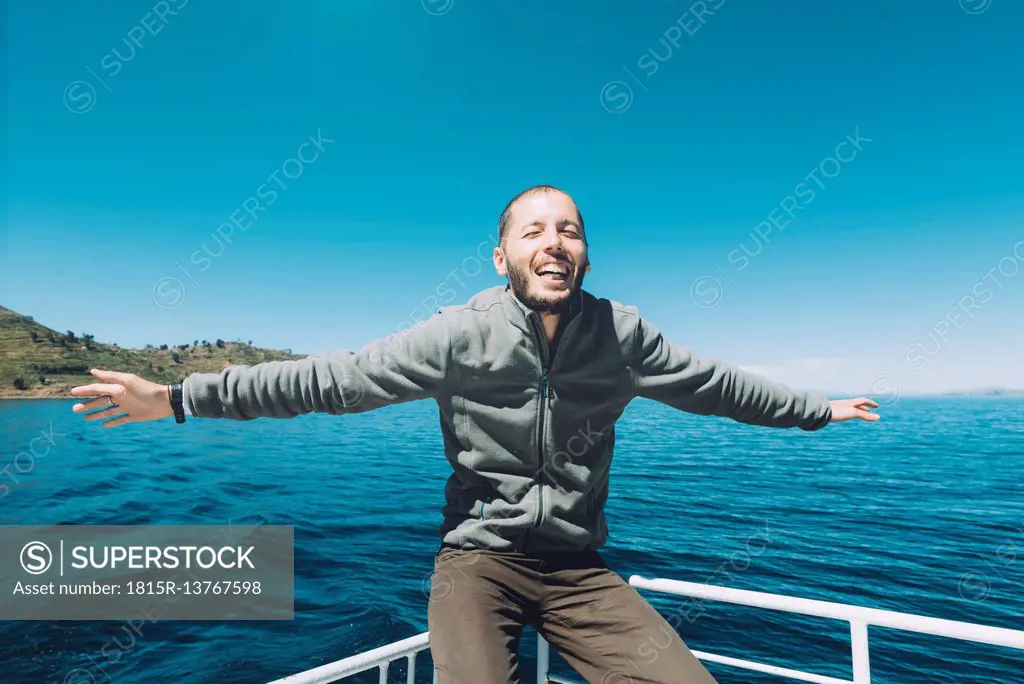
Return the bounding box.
[495,189,590,313]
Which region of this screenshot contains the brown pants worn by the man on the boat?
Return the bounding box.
[427,547,717,684]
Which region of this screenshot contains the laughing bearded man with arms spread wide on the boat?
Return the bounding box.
[72,185,879,684]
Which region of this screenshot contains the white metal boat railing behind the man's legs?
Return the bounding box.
[270,574,1024,684]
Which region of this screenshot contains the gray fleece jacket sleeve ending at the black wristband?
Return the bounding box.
[182,311,451,421]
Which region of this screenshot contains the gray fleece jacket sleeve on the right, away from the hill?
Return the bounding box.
[633,316,831,431]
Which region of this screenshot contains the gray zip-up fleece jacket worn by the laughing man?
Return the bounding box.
[184,286,831,552]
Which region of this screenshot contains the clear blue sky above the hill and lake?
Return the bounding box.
[0,0,1024,393]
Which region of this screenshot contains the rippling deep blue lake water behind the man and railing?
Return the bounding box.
[0,397,1024,684]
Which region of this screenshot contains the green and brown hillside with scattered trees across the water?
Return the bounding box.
[0,306,304,397]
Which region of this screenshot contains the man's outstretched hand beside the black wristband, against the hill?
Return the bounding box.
[71,369,174,427]
